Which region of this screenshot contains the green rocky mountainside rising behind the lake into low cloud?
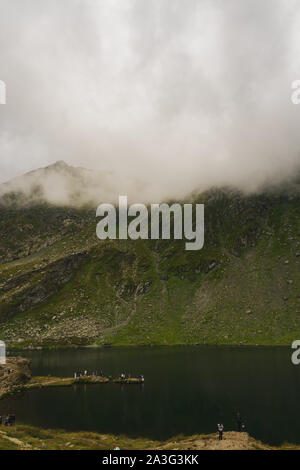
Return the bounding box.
[0,162,300,347]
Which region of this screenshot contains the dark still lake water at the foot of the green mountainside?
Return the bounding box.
[0,347,300,444]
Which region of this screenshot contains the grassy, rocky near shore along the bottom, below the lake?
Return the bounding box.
[0,425,300,451]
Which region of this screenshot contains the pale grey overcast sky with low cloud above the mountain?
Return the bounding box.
[0,0,300,196]
